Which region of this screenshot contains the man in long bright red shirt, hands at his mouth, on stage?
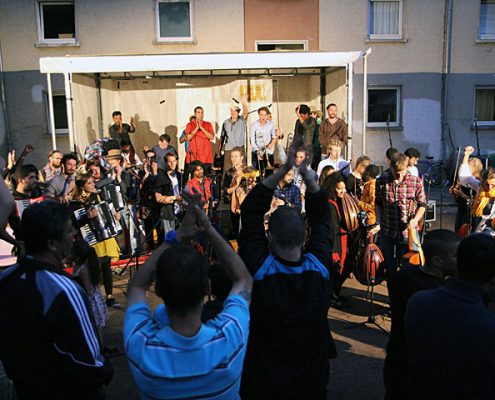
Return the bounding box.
[186,106,215,176]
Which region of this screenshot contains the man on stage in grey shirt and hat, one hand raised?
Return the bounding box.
[220,94,248,172]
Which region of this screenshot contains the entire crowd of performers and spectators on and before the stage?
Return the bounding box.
[0,97,495,399]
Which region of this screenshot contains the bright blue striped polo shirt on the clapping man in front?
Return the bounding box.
[124,295,249,399]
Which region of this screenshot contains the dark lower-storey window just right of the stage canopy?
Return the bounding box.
[367,86,400,127]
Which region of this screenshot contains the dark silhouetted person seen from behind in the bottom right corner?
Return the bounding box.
[404,233,495,400]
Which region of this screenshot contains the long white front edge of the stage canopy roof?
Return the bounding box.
[40,51,365,73]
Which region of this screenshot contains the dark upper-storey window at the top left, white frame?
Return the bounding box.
[36,0,76,44]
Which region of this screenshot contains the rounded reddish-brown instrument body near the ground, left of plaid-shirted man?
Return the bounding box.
[354,241,386,286]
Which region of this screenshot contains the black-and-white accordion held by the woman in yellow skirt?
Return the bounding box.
[74,201,122,245]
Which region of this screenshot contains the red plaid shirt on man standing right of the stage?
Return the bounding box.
[375,170,426,237]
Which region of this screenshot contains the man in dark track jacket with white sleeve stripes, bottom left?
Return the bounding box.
[0,201,112,400]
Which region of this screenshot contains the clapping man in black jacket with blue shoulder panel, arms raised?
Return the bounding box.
[239,138,334,400]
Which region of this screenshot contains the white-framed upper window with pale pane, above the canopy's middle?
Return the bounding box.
[156,0,194,42]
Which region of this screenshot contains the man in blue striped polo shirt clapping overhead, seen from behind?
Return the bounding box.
[124,193,252,399]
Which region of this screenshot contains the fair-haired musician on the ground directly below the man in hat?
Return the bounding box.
[223,146,246,239]
